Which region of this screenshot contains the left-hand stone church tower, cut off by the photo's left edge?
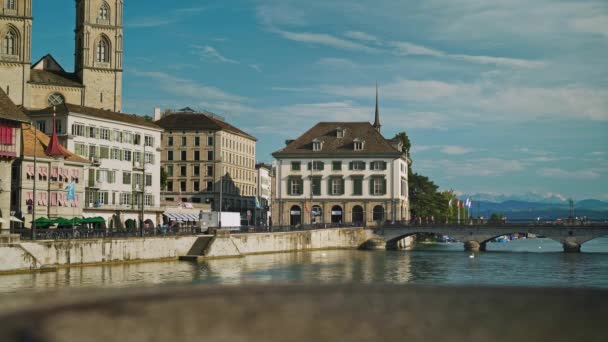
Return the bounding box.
[0,0,32,105]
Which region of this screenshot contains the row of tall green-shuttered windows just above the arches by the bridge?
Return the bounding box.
[287,177,386,196]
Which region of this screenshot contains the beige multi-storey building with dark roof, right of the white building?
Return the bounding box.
[155,108,257,213]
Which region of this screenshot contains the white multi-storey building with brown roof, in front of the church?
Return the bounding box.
[28,104,162,227]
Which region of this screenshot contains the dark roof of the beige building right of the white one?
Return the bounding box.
[156,113,257,140]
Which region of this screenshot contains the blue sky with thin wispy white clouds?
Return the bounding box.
[32,0,608,200]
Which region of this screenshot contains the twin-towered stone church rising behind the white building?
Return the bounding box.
[0,0,123,112]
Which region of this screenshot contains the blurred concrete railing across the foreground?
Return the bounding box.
[0,284,608,342]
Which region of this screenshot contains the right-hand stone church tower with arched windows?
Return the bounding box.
[74,0,123,112]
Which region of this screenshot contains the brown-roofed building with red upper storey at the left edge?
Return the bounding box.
[0,89,30,232]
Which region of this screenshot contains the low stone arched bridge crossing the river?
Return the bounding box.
[374,223,608,252]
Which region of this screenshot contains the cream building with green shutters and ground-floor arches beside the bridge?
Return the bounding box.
[272,90,410,226]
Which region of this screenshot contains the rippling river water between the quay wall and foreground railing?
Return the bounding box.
[0,237,608,296]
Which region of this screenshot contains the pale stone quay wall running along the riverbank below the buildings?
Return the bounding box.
[0,228,384,273]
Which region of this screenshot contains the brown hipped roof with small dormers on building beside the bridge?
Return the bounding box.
[272,122,401,157]
